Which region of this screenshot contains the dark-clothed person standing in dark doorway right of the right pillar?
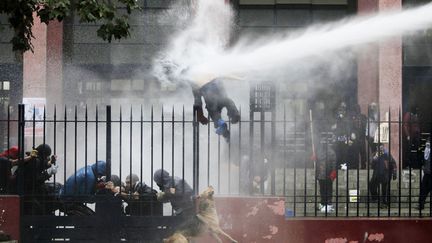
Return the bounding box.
[403,105,421,168]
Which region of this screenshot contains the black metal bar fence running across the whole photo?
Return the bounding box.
[0,105,432,217]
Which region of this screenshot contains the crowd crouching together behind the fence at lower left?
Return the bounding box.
[0,144,194,218]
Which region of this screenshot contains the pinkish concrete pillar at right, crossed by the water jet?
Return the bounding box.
[358,0,402,163]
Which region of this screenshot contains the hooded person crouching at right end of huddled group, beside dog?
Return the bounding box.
[153,169,195,216]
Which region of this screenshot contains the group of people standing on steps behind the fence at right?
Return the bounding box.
[311,99,432,212]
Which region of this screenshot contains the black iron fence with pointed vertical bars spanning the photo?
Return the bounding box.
[0,105,432,220]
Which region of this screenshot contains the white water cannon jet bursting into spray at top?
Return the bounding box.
[155,0,432,85]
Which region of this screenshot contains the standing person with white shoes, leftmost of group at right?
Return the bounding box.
[313,143,336,212]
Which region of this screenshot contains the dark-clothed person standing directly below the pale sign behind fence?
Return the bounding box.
[369,145,396,207]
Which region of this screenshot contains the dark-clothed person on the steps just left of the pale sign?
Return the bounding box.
[348,104,367,169]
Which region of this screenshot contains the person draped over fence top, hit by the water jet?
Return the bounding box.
[192,79,240,141]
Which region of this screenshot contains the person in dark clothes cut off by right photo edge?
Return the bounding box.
[417,138,432,210]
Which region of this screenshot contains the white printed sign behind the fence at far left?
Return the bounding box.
[23,98,46,137]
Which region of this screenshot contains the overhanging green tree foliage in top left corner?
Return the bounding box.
[0,0,139,52]
